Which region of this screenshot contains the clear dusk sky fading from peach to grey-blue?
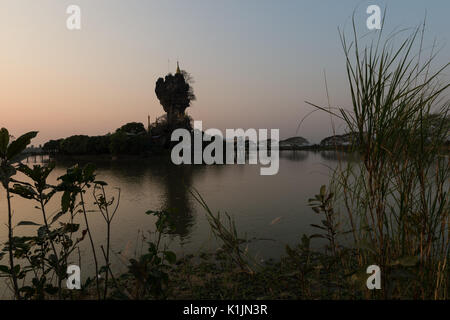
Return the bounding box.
[0,0,450,144]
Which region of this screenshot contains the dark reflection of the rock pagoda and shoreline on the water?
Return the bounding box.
[46,151,355,240]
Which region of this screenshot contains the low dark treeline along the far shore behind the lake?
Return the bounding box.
[41,119,450,158]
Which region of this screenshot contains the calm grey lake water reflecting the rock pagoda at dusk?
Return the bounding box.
[0,151,355,298]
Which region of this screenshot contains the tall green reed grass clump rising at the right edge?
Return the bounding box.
[310,19,450,299]
